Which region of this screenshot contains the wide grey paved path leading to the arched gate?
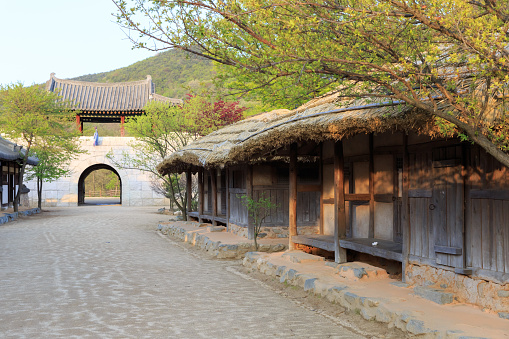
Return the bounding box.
[0,206,362,338]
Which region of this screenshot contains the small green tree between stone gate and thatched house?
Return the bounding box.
[107,96,244,217]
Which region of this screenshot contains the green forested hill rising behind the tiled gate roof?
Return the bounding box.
[73,50,215,99]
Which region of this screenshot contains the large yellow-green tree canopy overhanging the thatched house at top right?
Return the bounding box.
[114,0,509,166]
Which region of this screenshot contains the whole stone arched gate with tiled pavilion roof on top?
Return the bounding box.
[27,73,182,206]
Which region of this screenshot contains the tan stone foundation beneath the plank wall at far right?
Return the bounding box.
[405,265,509,317]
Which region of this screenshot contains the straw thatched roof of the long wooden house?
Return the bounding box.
[157,95,434,174]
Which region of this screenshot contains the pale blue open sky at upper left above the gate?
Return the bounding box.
[0,0,155,85]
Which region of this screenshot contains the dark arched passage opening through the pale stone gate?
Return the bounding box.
[78,164,122,206]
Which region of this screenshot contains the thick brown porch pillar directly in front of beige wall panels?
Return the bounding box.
[334,140,346,264]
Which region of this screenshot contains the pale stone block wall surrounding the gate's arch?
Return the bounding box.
[26,137,170,207]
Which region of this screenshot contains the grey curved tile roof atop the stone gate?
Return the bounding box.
[46,73,182,112]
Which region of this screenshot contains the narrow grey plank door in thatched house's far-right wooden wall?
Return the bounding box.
[429,146,465,267]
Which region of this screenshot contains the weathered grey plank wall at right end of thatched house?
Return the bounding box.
[409,140,509,281]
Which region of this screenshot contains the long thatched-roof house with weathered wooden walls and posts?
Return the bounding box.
[158,91,509,309]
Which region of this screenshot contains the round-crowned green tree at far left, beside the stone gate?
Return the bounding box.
[0,83,76,211]
